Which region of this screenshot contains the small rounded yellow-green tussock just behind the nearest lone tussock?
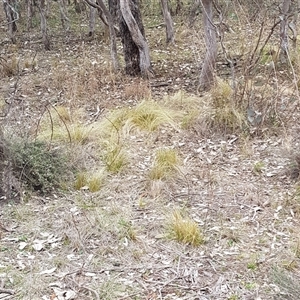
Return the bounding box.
[149,148,179,180]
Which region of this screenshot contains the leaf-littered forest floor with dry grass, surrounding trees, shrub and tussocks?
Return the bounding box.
[0,4,300,300]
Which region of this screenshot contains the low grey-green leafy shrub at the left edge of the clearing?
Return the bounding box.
[10,141,68,193]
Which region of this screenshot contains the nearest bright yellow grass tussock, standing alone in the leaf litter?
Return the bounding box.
[167,210,204,246]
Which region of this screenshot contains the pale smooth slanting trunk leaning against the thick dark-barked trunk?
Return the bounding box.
[120,0,152,77]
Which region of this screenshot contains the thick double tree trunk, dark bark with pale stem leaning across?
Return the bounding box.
[120,0,152,77]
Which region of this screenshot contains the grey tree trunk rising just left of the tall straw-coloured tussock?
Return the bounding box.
[199,0,217,89]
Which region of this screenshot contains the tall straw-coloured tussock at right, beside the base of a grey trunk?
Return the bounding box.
[211,79,246,131]
